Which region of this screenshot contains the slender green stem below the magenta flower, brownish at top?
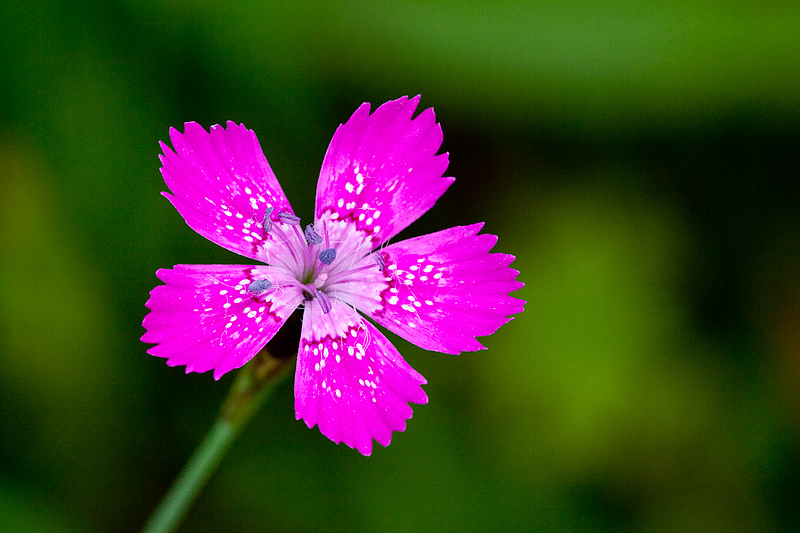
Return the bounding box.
[142,350,293,533]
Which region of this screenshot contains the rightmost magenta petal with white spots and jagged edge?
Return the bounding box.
[362,224,525,354]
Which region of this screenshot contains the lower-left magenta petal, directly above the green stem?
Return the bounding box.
[142,265,302,379]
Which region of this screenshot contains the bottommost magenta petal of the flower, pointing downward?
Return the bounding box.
[294,300,428,455]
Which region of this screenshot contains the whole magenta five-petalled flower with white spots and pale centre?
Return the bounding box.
[142,97,524,455]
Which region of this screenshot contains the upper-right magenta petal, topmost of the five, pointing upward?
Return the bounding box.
[316,96,454,248]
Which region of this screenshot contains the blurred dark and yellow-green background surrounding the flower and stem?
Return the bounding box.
[0,0,800,532]
